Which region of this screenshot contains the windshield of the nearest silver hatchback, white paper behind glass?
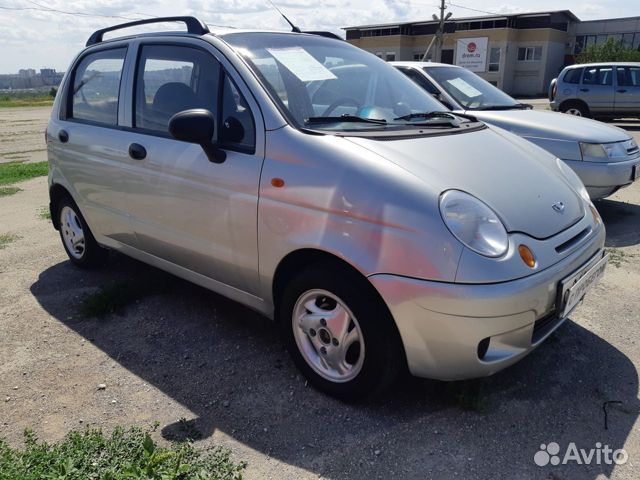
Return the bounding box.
[224,33,452,131]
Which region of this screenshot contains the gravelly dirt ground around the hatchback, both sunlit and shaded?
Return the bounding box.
[0,106,640,480]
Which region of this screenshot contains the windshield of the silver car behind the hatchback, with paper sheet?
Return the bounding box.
[424,67,520,110]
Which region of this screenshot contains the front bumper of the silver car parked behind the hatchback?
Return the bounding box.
[563,157,640,200]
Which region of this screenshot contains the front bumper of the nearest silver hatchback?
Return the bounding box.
[369,224,605,380]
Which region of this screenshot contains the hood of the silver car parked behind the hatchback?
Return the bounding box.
[466,110,631,143]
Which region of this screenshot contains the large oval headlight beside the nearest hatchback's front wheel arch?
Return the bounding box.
[440,190,509,257]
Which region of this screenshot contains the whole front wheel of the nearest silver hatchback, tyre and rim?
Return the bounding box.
[278,265,404,401]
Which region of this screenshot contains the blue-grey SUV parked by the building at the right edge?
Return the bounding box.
[549,63,640,119]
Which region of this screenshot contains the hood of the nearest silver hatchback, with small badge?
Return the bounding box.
[348,128,584,238]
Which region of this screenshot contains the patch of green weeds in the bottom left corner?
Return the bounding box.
[0,427,245,480]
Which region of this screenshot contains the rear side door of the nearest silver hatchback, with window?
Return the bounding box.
[48,44,134,243]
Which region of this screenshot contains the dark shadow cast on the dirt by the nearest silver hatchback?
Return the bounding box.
[31,255,639,479]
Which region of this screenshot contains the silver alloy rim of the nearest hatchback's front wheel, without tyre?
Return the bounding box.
[292,290,364,383]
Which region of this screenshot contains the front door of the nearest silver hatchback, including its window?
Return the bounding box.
[120,41,264,294]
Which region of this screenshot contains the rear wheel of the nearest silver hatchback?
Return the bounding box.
[58,197,108,268]
